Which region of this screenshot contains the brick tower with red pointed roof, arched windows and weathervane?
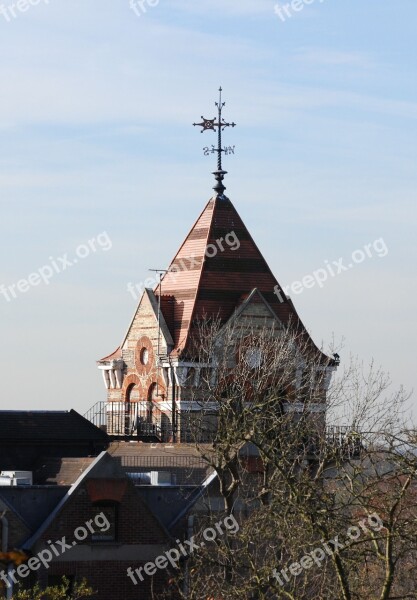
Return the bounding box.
[98,88,335,442]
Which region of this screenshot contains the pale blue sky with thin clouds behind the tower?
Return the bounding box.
[0,0,417,416]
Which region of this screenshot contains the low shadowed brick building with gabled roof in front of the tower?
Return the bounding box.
[0,452,176,600]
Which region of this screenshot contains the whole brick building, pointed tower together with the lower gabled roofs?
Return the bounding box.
[0,96,336,600]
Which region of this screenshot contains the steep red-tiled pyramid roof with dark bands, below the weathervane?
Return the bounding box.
[155,196,324,354]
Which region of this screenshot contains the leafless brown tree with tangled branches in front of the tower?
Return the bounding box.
[167,317,417,600]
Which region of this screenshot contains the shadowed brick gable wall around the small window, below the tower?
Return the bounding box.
[28,479,171,600]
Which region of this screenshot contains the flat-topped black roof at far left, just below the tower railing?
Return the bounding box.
[0,410,108,443]
